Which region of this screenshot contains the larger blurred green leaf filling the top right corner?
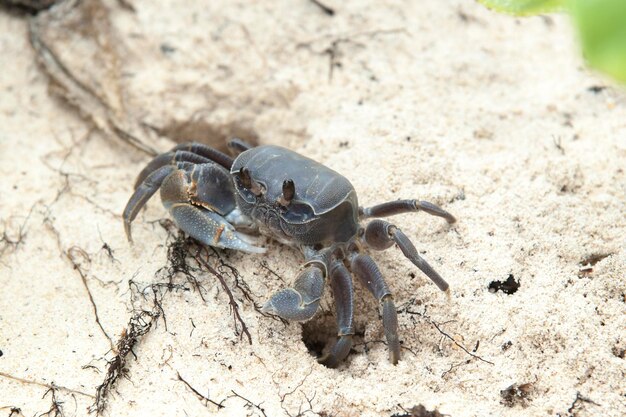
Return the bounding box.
[568,0,626,82]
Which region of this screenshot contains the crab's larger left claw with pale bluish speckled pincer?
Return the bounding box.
[161,170,265,253]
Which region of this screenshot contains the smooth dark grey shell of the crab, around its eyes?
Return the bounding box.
[230,146,359,245]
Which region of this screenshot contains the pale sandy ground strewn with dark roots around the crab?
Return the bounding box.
[0,0,626,417]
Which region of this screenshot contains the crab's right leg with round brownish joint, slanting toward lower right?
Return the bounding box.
[365,220,449,291]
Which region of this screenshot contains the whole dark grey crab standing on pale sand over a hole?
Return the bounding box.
[123,139,456,368]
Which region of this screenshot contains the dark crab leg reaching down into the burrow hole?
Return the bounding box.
[318,261,354,368]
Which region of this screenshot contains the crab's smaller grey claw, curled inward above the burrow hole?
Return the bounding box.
[262,263,324,321]
